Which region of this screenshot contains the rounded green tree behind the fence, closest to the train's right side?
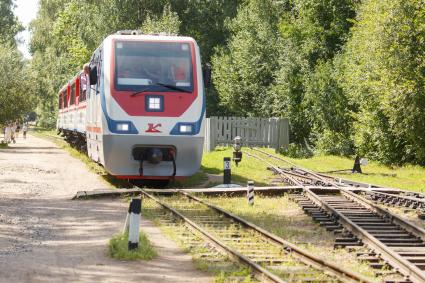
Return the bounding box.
[212,0,279,116]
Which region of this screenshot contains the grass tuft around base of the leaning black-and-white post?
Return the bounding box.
[109,231,156,260]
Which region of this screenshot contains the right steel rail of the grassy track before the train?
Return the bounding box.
[179,190,371,282]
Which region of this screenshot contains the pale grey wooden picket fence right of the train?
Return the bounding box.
[204,117,289,152]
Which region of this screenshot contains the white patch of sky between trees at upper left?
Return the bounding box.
[14,0,39,58]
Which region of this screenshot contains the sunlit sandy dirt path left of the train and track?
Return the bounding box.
[0,136,212,283]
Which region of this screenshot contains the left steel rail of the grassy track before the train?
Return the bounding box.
[140,189,285,283]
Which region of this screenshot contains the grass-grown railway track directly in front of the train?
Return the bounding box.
[141,190,369,282]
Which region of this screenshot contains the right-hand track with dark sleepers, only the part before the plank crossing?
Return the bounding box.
[298,189,425,282]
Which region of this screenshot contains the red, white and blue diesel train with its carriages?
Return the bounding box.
[57,31,208,181]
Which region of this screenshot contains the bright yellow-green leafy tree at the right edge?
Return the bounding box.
[341,0,425,164]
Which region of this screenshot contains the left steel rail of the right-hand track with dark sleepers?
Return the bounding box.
[305,189,425,283]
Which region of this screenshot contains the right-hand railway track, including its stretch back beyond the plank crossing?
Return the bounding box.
[245,150,425,282]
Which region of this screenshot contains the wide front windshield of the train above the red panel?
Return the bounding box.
[115,41,193,92]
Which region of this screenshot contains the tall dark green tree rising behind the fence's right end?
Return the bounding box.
[269,0,356,151]
